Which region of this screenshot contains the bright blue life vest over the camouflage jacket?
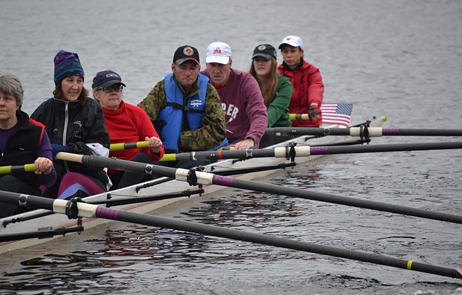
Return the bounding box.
[155,73,228,153]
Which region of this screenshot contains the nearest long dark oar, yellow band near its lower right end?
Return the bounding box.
[0,191,462,279]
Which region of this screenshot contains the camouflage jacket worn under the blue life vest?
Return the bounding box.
[138,77,226,152]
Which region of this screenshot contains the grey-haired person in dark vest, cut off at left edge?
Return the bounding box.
[0,74,56,218]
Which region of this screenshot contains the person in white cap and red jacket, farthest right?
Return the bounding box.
[278,36,324,127]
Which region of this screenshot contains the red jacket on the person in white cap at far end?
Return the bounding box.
[278,61,324,127]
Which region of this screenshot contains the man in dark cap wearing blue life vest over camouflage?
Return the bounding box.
[138,45,228,168]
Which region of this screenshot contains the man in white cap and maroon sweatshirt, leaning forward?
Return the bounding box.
[201,42,268,150]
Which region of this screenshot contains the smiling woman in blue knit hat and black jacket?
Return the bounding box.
[31,50,111,199]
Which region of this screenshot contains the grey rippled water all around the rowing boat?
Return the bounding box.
[0,0,462,295]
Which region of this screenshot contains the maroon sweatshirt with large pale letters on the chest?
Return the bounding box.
[201,69,268,148]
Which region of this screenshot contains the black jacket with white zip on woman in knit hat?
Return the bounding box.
[31,98,111,193]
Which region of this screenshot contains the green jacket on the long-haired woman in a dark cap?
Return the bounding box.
[268,73,293,127]
